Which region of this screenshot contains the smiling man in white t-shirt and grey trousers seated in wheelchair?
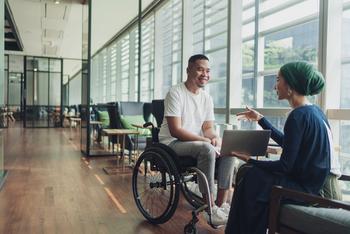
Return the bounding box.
[159,54,235,225]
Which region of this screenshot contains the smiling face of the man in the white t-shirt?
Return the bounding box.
[187,59,210,88]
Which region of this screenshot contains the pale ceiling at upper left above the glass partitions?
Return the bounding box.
[5,0,152,59]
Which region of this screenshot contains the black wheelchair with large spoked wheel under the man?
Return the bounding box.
[132,100,218,234]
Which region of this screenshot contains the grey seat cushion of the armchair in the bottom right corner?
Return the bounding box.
[279,205,350,234]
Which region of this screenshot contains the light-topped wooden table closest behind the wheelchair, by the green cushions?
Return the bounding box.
[102,129,139,164]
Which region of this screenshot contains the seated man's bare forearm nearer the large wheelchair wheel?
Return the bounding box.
[165,116,211,142]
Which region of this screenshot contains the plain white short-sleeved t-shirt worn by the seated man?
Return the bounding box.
[159,83,214,144]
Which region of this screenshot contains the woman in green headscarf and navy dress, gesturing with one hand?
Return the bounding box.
[226,62,340,234]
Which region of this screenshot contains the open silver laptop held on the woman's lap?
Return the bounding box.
[220,130,271,156]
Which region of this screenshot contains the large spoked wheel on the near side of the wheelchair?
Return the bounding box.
[132,147,180,224]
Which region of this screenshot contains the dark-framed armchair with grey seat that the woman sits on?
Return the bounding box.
[269,176,350,234]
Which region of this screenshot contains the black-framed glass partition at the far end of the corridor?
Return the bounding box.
[23,56,63,127]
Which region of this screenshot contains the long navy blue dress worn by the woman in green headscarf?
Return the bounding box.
[225,105,330,234]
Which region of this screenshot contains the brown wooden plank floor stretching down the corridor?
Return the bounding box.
[0,127,224,234]
